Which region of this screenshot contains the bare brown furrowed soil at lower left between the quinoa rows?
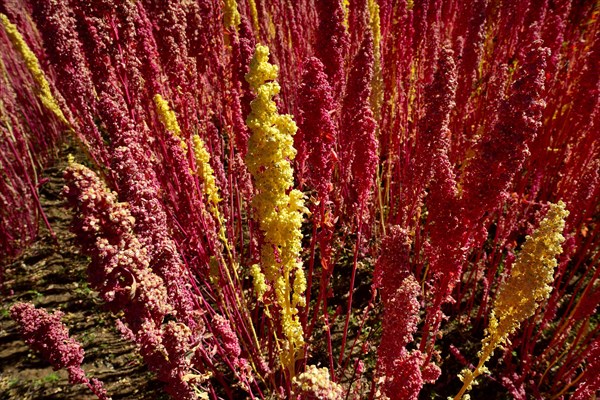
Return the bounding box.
[0,154,168,400]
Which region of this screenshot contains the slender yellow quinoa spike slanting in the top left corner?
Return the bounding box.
[0,13,71,126]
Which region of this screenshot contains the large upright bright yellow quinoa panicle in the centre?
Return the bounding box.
[246,45,306,376]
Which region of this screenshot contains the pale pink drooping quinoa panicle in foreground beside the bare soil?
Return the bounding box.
[63,163,201,399]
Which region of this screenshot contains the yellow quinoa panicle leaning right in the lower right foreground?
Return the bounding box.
[454,201,569,400]
